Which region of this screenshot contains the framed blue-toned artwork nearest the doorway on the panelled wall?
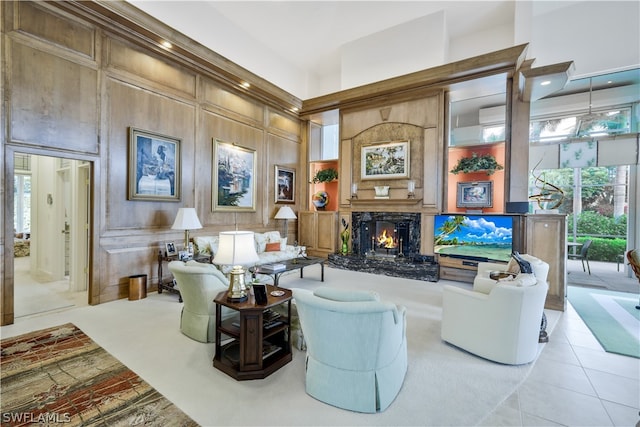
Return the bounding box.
[127,127,181,202]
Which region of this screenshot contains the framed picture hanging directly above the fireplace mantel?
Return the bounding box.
[360,141,409,179]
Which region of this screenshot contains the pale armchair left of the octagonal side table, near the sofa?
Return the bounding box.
[169,261,233,342]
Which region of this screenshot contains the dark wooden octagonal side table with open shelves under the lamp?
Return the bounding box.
[213,285,292,381]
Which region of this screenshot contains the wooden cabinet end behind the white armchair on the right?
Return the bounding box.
[524,214,567,311]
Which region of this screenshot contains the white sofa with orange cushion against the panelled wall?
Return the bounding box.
[193,231,306,273]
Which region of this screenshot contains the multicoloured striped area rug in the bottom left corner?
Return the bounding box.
[0,323,197,426]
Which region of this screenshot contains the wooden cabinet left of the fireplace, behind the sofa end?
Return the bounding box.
[298,211,338,258]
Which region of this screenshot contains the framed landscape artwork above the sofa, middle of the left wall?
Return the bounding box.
[211,139,256,211]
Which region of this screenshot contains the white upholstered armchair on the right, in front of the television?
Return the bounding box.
[441,274,549,365]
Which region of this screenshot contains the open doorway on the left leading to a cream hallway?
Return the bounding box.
[13,153,91,318]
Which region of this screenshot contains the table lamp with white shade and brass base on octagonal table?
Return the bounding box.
[213,231,259,302]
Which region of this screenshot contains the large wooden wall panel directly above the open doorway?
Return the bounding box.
[7,42,98,154]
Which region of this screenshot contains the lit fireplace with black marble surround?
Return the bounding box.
[351,212,420,258]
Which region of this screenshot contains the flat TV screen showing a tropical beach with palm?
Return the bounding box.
[434,214,513,261]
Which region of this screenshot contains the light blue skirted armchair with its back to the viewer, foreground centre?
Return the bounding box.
[293,287,407,412]
